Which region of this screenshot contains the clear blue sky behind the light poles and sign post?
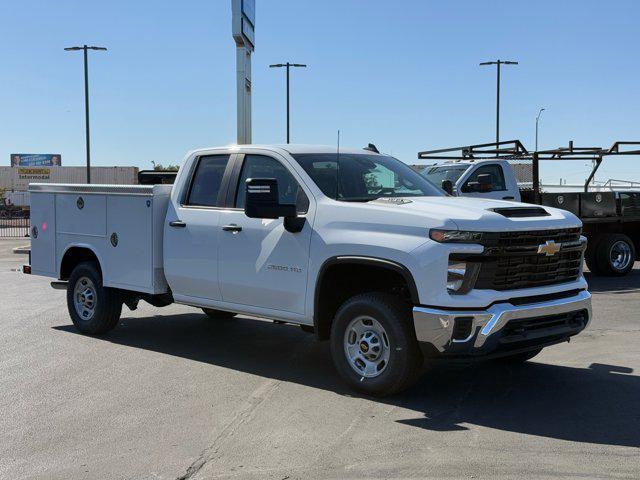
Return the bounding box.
[0,0,640,182]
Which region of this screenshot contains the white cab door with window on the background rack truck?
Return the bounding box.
[456,162,520,202]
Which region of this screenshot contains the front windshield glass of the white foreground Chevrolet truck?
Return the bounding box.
[293,153,444,202]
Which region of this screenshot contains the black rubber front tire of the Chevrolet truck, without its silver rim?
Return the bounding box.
[330,293,423,397]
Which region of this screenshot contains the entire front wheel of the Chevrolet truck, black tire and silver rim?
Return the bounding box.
[331,293,422,396]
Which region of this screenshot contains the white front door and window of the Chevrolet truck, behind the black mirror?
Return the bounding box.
[218,152,315,315]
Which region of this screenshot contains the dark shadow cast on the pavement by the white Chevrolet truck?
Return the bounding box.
[53,314,640,447]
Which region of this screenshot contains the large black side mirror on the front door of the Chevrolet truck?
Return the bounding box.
[244,178,297,219]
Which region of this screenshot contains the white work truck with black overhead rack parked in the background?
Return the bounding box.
[416,152,640,276]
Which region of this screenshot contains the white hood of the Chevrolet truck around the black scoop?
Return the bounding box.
[368,196,582,232]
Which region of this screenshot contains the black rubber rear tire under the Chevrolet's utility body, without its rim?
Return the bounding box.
[67,262,122,335]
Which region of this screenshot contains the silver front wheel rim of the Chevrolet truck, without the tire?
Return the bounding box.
[343,315,391,378]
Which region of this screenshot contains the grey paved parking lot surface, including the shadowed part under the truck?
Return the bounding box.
[0,240,640,480]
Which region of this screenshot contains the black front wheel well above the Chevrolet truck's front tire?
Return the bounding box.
[313,257,419,340]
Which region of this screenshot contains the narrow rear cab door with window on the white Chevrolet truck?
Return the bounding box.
[163,154,235,304]
